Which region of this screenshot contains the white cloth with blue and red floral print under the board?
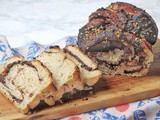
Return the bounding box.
[0,36,160,120]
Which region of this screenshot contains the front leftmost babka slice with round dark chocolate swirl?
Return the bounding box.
[0,56,56,113]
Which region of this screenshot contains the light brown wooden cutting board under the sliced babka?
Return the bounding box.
[0,40,160,120]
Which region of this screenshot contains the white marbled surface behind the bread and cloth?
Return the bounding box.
[0,0,160,47]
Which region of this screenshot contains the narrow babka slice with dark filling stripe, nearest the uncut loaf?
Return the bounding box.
[63,45,102,86]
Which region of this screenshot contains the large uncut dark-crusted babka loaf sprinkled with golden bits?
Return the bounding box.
[78,2,158,76]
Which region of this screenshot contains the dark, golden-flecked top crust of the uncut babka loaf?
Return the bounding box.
[78,2,158,51]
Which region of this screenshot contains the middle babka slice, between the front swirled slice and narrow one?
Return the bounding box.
[36,46,83,105]
